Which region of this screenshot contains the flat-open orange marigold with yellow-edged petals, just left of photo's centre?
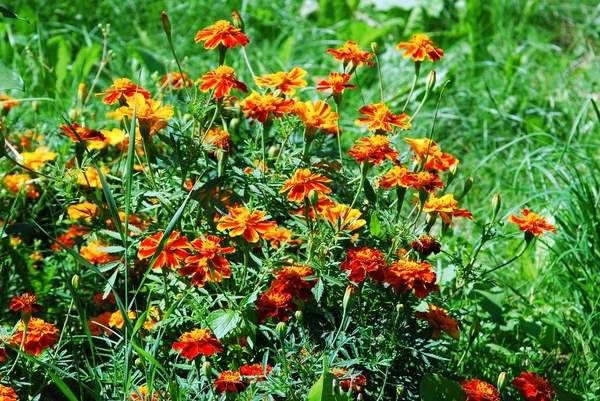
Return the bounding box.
[217,206,277,242]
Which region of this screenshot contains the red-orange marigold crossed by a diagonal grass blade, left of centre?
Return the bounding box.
[138,231,190,269]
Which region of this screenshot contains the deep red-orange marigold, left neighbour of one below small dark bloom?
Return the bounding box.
[341,246,387,284]
